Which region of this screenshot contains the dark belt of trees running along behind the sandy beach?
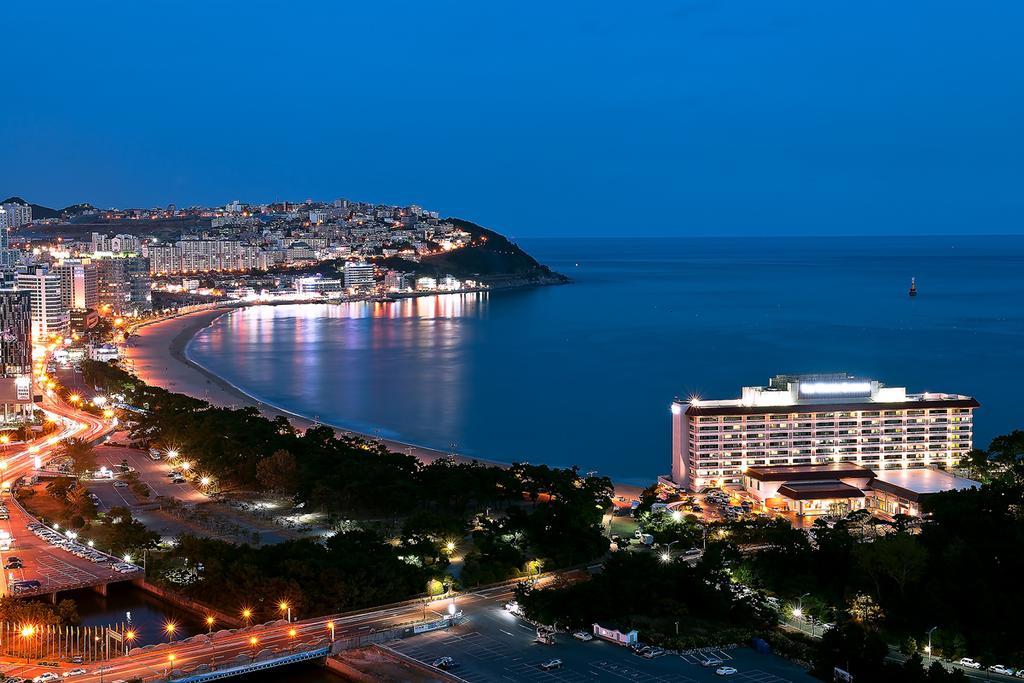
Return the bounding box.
[83,362,612,610]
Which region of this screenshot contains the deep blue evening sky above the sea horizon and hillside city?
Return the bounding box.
[0,0,1024,237]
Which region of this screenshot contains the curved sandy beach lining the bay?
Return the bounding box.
[123,302,643,499]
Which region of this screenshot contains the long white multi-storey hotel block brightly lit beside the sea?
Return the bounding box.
[672,374,979,492]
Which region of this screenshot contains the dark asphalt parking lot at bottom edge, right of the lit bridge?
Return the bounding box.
[389,606,814,683]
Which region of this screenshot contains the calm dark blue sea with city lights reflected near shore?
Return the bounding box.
[188,237,1024,483]
